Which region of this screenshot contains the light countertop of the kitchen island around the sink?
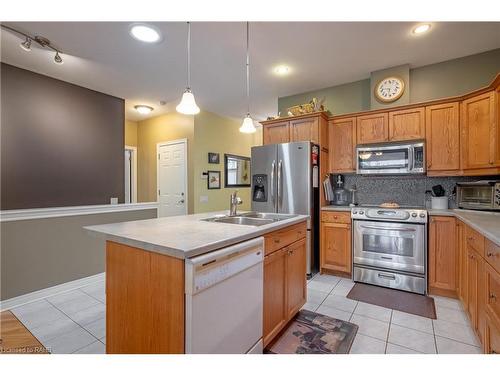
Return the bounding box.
[84,211,309,259]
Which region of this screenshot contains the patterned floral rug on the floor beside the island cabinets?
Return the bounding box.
[266,310,358,354]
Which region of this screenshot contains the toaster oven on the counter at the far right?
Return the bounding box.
[457,180,500,210]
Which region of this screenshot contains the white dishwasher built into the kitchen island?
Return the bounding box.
[185,237,264,354]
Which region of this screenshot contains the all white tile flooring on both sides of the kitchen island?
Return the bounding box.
[7,275,481,354]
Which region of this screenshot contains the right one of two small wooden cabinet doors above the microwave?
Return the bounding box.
[389,108,425,141]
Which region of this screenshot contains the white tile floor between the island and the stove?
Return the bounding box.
[304,275,481,354]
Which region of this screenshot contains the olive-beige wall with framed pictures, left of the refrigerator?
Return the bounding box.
[194,111,262,212]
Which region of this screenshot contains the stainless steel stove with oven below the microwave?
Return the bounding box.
[351,207,427,294]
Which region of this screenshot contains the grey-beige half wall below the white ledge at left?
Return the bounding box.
[0,209,156,300]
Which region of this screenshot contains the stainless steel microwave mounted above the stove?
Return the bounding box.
[356,141,425,175]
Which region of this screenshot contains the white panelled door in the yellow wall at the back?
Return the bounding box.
[157,140,187,217]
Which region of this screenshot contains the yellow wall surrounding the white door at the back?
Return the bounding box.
[137,112,194,213]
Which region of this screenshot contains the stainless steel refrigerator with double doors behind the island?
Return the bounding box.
[251,142,320,275]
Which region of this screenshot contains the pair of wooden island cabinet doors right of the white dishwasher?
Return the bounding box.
[263,224,307,346]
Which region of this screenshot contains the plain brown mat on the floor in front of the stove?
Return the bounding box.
[347,283,436,319]
